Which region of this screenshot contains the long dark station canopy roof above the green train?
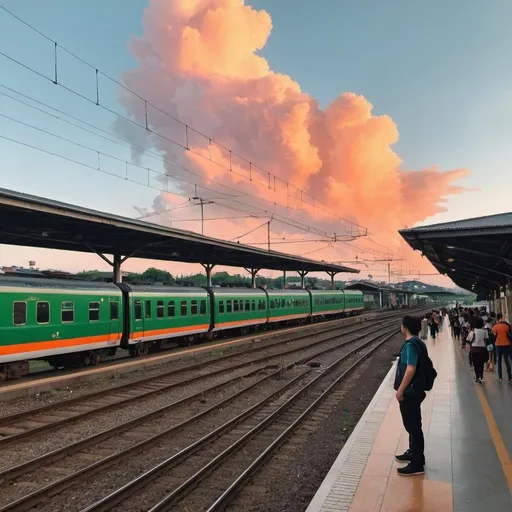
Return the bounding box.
[0,188,359,273]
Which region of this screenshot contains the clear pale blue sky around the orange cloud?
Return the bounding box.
[0,0,512,278]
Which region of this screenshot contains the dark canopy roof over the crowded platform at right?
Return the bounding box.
[400,213,512,298]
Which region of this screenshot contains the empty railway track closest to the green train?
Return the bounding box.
[0,310,416,448]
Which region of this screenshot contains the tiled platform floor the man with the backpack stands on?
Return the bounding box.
[306,324,512,512]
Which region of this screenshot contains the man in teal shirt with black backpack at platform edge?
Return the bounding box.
[395,316,437,476]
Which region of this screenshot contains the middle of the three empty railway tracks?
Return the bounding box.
[0,320,408,512]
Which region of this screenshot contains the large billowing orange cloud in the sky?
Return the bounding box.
[121,0,468,286]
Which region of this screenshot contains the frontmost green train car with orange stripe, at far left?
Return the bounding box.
[0,276,123,379]
